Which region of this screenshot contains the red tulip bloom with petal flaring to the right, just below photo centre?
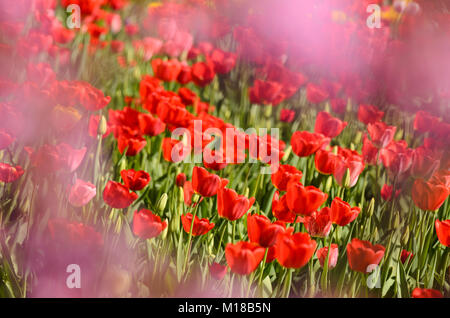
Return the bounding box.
[217,185,255,221]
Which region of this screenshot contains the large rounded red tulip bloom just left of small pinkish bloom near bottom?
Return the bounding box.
[275,231,317,268]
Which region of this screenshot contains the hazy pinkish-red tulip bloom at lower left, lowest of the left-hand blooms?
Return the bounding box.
[133,209,167,239]
